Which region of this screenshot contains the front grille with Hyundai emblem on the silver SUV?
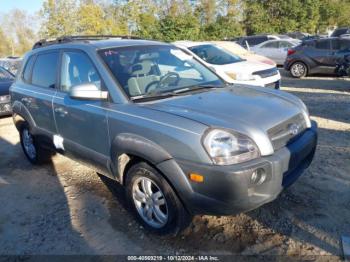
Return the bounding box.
[267,114,306,150]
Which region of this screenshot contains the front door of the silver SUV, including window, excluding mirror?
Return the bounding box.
[53,50,110,172]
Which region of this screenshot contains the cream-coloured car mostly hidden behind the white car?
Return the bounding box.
[210,41,276,66]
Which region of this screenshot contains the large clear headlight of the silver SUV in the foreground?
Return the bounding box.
[203,129,260,165]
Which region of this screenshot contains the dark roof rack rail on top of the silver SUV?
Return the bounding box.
[32,35,141,49]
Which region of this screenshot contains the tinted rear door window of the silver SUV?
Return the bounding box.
[32,52,59,88]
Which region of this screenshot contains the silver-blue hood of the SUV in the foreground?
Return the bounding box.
[144,85,303,155]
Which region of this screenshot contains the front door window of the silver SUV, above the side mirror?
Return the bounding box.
[60,51,101,92]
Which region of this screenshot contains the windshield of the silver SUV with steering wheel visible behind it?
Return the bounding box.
[99,45,223,98]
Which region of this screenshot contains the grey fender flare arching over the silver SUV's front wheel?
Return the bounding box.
[111,133,172,184]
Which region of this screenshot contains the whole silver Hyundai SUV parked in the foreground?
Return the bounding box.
[11,37,317,234]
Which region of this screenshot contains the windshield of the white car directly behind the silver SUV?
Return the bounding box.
[189,45,243,65]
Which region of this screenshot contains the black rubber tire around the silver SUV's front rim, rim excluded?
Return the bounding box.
[125,162,192,235]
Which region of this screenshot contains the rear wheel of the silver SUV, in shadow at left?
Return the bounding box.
[19,122,52,165]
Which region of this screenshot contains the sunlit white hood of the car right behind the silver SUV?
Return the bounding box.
[215,61,275,74]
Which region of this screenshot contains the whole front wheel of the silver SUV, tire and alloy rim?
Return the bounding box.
[125,162,192,235]
